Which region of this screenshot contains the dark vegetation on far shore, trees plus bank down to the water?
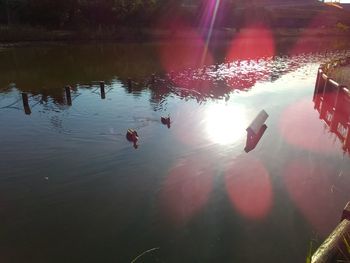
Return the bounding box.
[0,0,350,41]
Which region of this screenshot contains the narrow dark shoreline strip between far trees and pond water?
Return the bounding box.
[0,26,350,48]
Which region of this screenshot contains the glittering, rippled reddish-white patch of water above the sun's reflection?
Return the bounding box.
[146,51,348,109]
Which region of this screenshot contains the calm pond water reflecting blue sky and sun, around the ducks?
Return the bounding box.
[0,39,350,263]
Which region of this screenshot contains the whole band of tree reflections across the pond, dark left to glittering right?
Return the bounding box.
[0,40,348,111]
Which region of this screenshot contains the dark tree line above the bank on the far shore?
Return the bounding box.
[0,0,348,30]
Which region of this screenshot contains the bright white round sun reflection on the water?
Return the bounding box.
[206,104,248,145]
